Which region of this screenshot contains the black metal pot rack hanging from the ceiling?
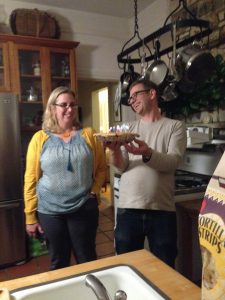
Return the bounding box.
[117,0,212,64]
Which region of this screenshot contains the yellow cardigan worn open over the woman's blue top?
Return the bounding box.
[24,127,106,224]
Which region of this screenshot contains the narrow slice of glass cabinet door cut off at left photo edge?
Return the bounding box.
[0,43,10,92]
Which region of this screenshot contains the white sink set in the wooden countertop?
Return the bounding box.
[11,265,170,300]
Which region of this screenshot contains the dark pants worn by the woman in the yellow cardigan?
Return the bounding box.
[38,198,99,270]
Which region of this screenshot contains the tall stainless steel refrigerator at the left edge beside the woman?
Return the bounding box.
[0,93,26,268]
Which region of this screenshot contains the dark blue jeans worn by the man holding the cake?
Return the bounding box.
[115,208,177,268]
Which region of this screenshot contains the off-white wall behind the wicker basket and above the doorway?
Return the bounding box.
[0,0,129,80]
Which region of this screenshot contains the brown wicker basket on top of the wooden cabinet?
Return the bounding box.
[10,8,60,38]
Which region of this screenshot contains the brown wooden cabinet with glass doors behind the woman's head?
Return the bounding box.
[0,34,79,132]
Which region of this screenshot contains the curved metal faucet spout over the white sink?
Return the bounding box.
[85,274,111,300]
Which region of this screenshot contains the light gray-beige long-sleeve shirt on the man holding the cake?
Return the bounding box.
[117,117,187,211]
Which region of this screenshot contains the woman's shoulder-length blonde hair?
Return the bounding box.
[42,86,81,133]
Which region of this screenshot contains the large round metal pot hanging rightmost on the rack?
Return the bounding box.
[175,42,215,83]
